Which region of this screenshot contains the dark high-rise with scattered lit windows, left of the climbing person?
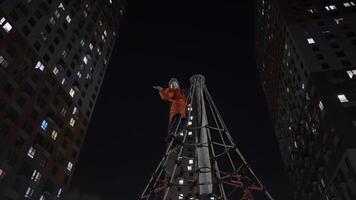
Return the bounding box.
[0,0,125,200]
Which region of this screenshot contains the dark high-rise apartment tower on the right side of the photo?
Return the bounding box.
[255,0,356,200]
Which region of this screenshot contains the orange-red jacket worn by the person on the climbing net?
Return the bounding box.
[159,88,187,122]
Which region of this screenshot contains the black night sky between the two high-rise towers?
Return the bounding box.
[72,0,291,200]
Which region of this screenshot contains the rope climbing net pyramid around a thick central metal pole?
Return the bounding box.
[139,75,273,200]
